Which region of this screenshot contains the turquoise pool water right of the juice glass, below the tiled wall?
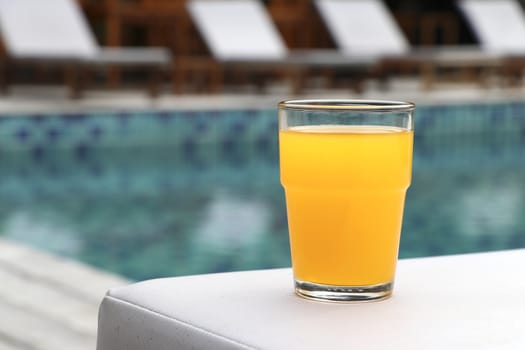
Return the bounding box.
[400,134,525,257]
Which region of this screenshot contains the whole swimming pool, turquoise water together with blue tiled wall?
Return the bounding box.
[0,102,525,279]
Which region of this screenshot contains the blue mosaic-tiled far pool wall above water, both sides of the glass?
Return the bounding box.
[0,102,525,158]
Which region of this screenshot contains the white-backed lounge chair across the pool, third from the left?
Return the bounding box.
[315,0,501,88]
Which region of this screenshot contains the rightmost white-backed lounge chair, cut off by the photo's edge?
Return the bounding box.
[457,0,525,82]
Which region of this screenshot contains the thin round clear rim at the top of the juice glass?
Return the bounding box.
[278,99,416,112]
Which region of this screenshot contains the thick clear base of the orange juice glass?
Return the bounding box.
[295,279,393,303]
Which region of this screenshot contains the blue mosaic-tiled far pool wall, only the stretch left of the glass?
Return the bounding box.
[0,110,277,153]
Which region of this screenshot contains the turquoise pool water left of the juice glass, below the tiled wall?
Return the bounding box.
[0,146,289,279]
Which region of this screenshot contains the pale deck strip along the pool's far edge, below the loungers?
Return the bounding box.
[0,78,525,114]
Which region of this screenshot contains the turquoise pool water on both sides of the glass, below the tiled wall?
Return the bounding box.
[0,120,525,279]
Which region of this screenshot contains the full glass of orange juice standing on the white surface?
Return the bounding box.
[279,100,415,302]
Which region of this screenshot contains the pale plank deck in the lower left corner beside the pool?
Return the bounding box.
[0,239,128,350]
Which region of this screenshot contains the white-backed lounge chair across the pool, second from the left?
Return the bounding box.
[183,0,375,92]
